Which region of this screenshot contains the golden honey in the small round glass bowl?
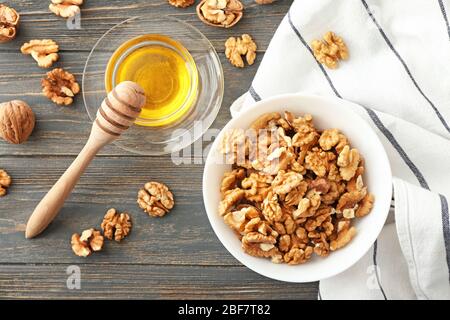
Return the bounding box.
[105,34,198,126]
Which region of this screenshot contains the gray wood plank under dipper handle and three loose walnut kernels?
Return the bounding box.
[0,157,232,265]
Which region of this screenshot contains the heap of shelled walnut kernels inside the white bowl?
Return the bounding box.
[218,112,374,265]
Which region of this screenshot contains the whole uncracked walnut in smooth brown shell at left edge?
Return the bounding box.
[0,100,35,144]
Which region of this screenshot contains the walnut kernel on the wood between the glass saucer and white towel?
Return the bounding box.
[225,34,257,68]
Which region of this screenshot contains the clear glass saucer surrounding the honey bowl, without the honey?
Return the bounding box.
[82,16,224,155]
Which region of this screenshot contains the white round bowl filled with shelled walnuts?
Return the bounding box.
[203,94,392,282]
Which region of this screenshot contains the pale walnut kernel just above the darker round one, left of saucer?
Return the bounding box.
[20,39,59,68]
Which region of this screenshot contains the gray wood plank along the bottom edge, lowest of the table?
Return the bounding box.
[0,264,317,299]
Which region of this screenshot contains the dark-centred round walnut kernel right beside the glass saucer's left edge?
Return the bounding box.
[41,68,80,106]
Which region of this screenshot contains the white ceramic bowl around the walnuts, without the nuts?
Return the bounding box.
[203,94,392,282]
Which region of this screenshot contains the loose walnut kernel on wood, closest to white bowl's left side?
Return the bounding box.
[137,181,175,217]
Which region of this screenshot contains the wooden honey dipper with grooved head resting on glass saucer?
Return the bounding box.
[25,81,145,238]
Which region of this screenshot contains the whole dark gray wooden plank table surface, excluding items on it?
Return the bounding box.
[0,0,317,299]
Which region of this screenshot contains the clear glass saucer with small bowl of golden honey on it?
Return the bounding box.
[82,15,224,155]
